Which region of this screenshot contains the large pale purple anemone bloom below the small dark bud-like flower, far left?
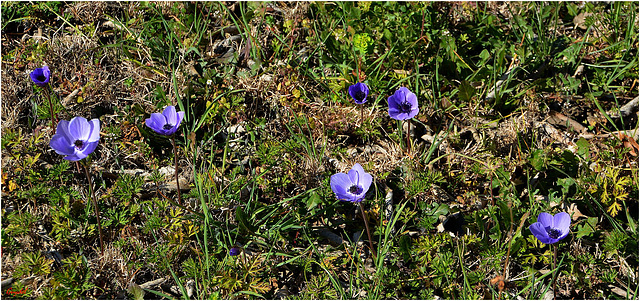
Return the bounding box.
[49,117,100,161]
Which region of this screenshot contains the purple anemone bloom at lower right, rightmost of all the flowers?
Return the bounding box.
[529,212,571,244]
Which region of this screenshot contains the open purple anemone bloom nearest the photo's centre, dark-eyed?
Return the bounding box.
[331,163,373,203]
